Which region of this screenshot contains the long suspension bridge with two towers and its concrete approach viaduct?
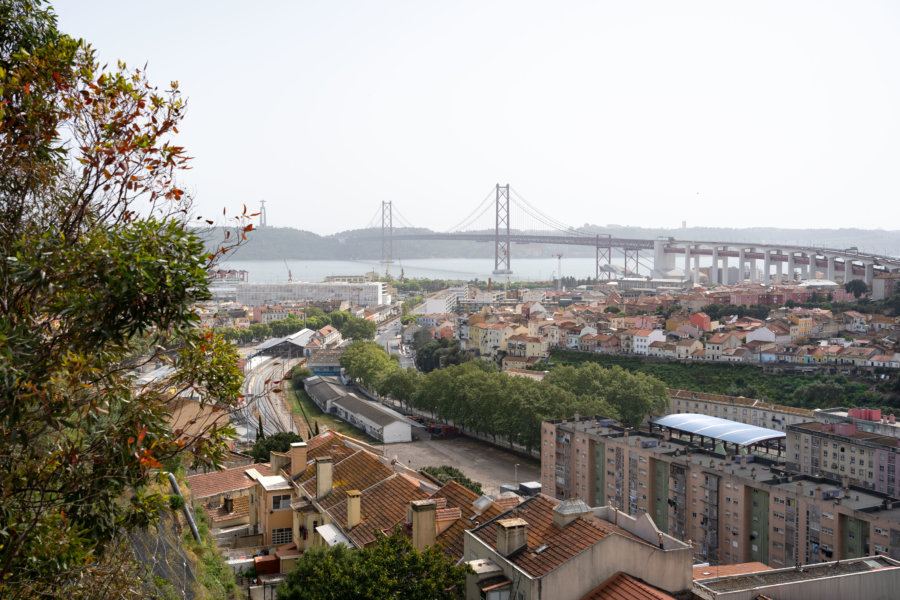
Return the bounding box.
[358,184,900,285]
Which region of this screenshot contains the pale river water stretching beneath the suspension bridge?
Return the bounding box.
[221,257,624,283]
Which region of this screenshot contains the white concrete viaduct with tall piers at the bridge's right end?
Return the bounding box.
[653,238,900,286]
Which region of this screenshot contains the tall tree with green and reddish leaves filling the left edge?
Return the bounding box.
[0,0,249,598]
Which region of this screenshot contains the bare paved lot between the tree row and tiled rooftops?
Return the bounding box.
[384,437,541,494]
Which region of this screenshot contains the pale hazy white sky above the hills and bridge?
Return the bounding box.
[53,0,900,234]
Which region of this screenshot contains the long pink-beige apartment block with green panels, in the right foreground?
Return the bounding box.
[541,418,900,568]
